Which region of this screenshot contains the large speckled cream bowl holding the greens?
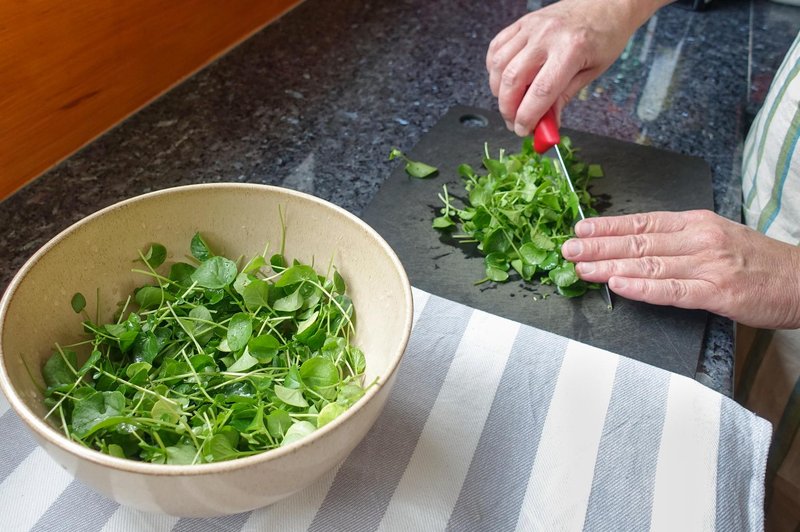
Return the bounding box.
[0,184,412,517]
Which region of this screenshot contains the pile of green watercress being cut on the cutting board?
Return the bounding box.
[432,137,603,297]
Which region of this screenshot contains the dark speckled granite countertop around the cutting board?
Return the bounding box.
[0,0,800,395]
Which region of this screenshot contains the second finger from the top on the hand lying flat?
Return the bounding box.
[561,233,706,262]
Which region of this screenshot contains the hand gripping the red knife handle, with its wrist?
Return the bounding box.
[486,0,673,136]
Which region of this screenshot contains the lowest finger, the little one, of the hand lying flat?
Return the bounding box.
[608,277,714,309]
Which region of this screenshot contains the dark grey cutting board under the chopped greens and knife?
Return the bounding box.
[363,107,713,377]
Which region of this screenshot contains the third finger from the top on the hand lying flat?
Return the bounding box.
[575,256,706,283]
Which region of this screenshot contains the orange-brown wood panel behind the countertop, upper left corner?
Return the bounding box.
[0,0,301,199]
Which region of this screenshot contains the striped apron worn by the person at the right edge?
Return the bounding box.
[735,33,800,530]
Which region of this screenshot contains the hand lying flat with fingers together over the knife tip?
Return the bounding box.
[561,211,800,329]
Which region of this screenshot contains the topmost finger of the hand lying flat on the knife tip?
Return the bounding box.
[575,211,708,237]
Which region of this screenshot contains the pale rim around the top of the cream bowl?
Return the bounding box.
[0,182,413,476]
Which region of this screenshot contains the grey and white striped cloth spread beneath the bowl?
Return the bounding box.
[0,289,770,532]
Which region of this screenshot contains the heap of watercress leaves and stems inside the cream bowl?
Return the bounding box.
[42,233,366,464]
